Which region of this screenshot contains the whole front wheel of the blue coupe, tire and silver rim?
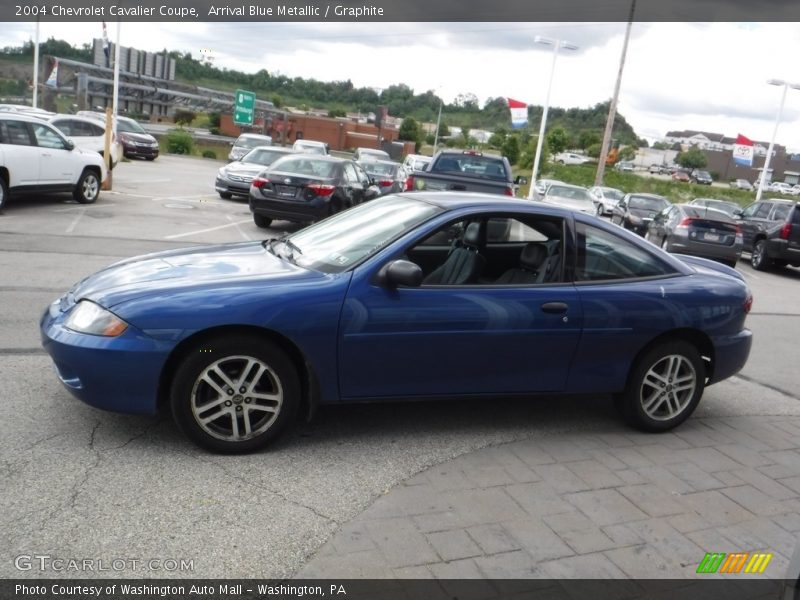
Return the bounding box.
[170,335,300,454]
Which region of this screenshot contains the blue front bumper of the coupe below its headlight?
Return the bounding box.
[39,301,173,414]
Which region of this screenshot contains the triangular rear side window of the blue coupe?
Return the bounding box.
[575,223,674,281]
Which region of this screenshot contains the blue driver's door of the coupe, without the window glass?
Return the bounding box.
[339,215,582,399]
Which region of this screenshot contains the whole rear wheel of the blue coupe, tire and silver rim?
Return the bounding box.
[617,341,705,432]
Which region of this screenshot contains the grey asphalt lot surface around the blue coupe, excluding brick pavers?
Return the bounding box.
[0,156,800,578]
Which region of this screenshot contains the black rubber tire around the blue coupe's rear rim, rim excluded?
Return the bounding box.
[617,340,705,432]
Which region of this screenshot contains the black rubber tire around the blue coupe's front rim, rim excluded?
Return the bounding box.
[170,334,300,454]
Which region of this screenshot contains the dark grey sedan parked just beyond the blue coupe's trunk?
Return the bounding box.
[645,204,742,267]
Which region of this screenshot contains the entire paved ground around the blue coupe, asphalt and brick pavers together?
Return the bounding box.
[0,156,800,578]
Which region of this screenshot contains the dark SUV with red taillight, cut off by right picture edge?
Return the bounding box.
[738,199,800,271]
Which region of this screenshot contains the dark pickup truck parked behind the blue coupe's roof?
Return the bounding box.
[406,150,527,196]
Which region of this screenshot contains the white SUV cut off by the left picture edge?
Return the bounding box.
[0,113,106,208]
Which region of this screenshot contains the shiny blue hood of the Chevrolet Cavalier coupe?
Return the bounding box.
[65,242,324,308]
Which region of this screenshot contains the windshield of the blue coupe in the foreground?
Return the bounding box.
[286,196,442,273]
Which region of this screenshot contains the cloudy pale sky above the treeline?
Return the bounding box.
[0,22,800,151]
